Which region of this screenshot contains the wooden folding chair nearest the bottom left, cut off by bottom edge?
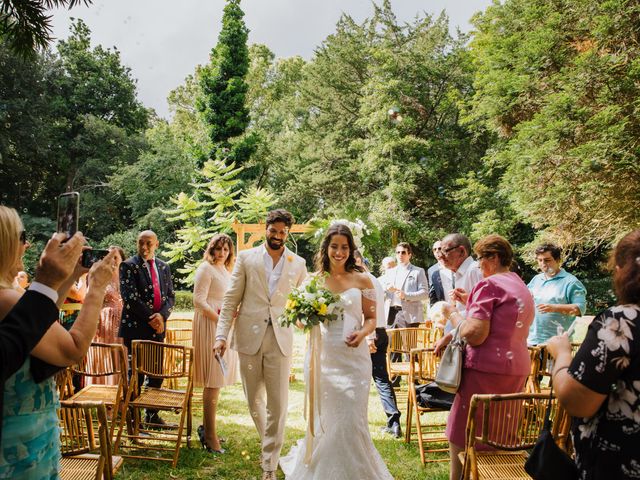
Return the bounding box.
[58,400,122,480]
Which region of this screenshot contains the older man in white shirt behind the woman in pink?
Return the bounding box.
[440,233,482,332]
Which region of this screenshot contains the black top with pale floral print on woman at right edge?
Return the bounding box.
[569,305,640,480]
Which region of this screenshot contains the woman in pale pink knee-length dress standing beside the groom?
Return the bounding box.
[193,233,238,453]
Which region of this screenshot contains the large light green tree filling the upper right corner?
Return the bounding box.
[470,0,640,255]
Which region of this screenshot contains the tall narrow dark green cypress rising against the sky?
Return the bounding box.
[197,0,254,166]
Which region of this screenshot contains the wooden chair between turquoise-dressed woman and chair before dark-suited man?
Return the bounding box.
[69,343,127,440]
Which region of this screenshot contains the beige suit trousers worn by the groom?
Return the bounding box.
[238,326,291,470]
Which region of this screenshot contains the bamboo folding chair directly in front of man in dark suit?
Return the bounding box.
[115,340,193,468]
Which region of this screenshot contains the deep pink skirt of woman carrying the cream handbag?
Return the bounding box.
[445,368,527,450]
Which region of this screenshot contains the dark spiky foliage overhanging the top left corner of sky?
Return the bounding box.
[0,0,91,57]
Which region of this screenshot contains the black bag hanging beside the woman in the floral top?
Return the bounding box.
[524,385,578,480]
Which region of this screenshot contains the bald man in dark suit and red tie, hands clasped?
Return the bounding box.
[119,230,175,425]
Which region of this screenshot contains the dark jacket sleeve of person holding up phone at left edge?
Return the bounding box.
[0,290,58,441]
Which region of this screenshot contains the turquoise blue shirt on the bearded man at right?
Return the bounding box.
[527,269,587,345]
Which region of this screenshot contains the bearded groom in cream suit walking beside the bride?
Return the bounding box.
[214,210,307,480]
